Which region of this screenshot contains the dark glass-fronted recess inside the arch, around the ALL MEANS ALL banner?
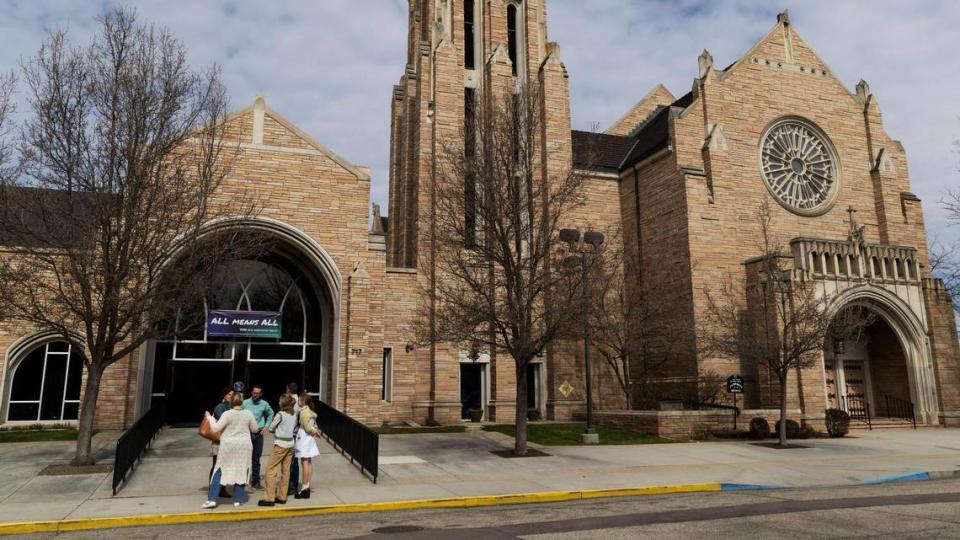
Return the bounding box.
[152,259,322,425]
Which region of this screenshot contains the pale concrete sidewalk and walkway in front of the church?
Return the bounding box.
[0,428,960,523]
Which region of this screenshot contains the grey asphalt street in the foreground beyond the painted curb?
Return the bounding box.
[18,479,960,540]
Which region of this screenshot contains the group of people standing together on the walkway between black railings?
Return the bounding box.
[202,382,320,508]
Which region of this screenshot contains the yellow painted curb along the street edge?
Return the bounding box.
[0,482,721,535]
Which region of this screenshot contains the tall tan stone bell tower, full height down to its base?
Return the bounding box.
[386,0,572,423]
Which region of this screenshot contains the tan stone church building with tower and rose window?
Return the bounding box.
[0,0,960,428]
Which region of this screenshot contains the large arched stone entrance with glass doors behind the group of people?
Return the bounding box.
[140,220,340,425]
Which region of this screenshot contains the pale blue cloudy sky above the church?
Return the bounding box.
[0,0,960,239]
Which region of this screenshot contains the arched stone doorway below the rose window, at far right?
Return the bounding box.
[823,287,937,423]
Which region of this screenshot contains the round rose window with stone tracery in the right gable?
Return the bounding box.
[760,118,838,215]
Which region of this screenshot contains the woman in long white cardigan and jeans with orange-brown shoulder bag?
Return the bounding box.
[202,392,260,508]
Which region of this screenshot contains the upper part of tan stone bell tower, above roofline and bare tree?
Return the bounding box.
[387,0,570,268]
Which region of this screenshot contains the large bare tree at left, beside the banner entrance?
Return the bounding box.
[0,9,255,465]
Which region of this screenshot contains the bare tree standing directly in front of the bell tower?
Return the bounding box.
[417,83,582,455]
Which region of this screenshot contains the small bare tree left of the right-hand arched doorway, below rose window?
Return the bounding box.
[701,202,871,446]
